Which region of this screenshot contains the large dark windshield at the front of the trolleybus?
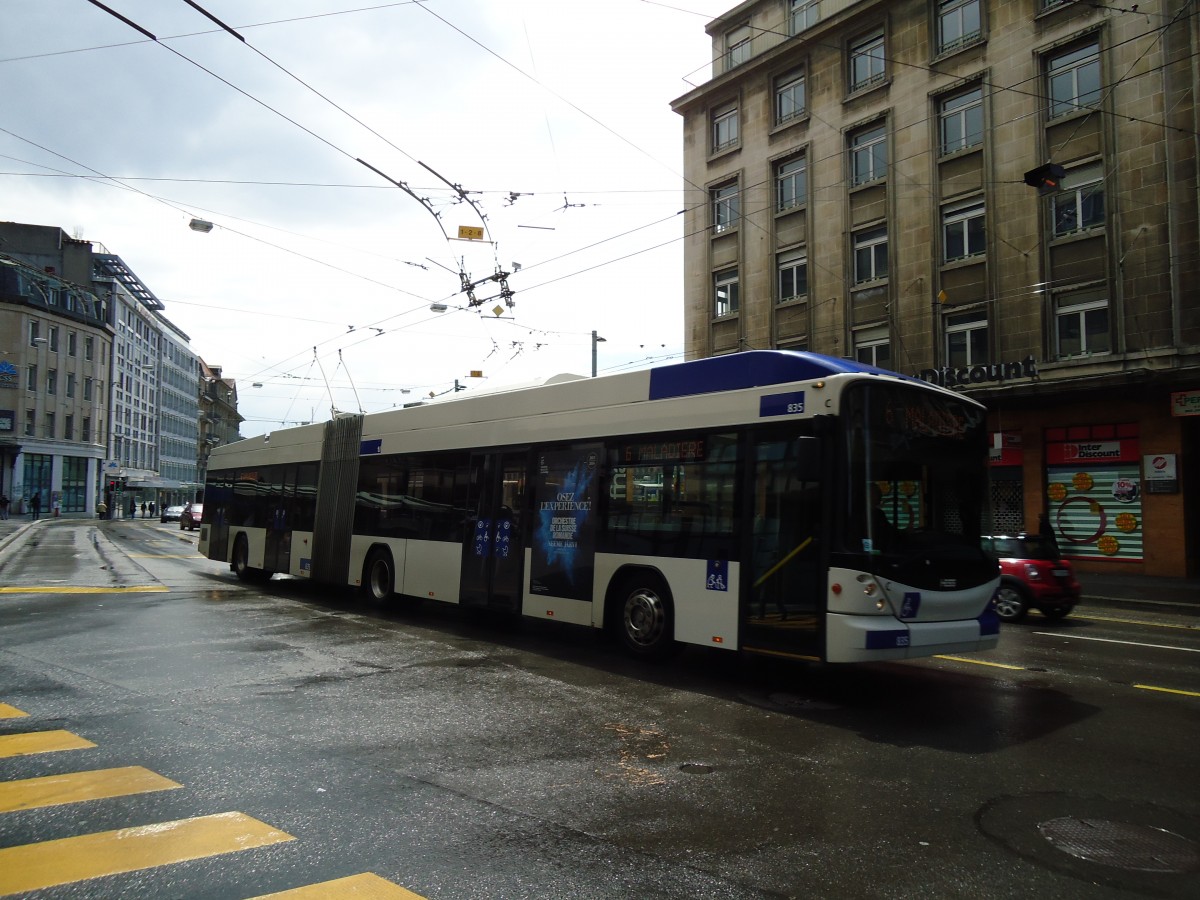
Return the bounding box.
[839,384,992,586]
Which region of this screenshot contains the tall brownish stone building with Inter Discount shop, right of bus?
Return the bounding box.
[672,0,1200,576]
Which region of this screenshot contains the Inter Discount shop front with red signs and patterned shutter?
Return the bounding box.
[984,384,1200,577]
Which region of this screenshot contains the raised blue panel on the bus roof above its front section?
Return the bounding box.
[649,350,911,400]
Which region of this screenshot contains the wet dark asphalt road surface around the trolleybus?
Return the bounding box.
[0,521,1200,900]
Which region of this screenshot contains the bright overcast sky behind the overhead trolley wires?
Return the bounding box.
[0,0,720,436]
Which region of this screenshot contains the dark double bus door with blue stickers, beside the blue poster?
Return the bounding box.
[458,451,529,612]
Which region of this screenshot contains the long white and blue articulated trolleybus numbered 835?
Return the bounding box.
[200,350,998,662]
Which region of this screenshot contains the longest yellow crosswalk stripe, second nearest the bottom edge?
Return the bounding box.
[0,812,295,894]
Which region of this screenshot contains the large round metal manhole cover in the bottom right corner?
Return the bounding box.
[1038,816,1200,872]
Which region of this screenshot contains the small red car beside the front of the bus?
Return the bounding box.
[983,534,1081,622]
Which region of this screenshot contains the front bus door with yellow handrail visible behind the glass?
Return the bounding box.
[742,433,826,658]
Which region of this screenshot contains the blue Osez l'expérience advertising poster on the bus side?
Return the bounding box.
[529,446,600,600]
